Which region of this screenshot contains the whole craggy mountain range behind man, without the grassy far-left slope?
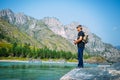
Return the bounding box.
[0,9,120,62]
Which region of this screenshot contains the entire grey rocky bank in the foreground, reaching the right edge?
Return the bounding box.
[60,62,120,80]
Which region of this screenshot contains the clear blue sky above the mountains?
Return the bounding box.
[0,0,120,46]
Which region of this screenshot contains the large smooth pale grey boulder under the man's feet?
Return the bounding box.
[60,68,111,80]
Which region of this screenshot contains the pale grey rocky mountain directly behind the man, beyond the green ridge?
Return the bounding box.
[43,17,120,62]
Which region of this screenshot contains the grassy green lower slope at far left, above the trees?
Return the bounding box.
[0,19,38,45]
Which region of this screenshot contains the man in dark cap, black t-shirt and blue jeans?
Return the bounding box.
[74,25,85,68]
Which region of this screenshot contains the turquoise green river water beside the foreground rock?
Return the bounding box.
[0,62,96,80]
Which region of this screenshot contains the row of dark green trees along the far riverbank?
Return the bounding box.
[0,42,77,60]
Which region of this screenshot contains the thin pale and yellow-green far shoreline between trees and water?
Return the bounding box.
[0,57,111,64]
